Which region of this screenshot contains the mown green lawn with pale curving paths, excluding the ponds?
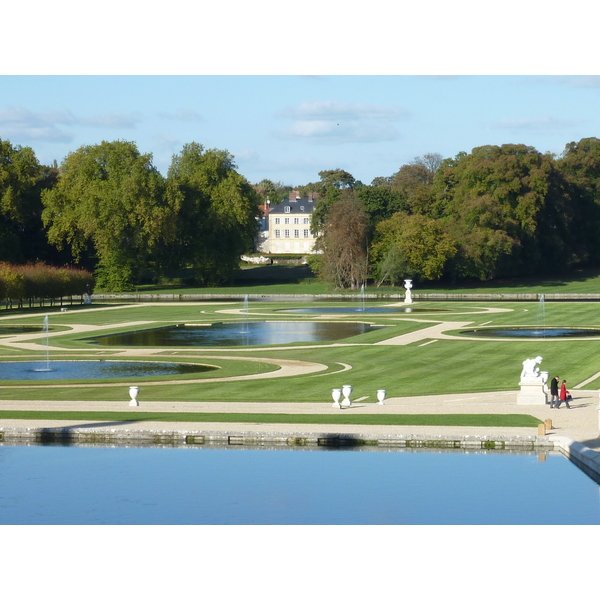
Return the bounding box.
[0,284,600,422]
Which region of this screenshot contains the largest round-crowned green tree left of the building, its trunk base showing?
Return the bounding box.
[42,141,171,291]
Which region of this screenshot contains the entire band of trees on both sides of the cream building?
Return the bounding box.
[0,138,600,291]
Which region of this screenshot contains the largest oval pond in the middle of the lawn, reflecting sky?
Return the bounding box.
[90,321,375,346]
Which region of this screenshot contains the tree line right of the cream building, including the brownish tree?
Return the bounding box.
[298,138,600,289]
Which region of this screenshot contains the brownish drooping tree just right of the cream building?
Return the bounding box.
[316,190,367,290]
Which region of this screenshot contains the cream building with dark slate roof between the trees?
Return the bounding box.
[256,190,318,254]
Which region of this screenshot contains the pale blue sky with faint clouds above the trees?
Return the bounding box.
[0,75,600,186]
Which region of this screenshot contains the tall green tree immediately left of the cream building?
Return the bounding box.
[159,142,260,285]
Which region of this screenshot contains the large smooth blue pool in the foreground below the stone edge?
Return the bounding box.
[0,446,600,525]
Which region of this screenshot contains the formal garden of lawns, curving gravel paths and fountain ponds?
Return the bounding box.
[0,276,600,426]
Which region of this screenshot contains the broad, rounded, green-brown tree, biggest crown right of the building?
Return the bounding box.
[434,144,580,279]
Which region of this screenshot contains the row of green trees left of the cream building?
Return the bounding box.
[0,140,259,291]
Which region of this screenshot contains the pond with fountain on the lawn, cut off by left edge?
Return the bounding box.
[0,360,216,381]
